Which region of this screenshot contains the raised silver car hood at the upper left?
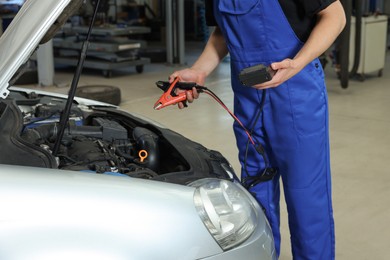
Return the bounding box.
[0,0,83,98]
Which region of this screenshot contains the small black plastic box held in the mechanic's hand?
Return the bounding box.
[238,64,276,87]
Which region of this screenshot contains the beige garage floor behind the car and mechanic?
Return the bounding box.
[19,47,390,260]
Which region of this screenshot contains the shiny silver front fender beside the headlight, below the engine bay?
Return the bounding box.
[0,165,223,260]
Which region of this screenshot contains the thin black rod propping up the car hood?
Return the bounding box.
[53,0,100,156]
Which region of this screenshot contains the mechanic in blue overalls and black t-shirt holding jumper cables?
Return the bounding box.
[170,0,345,260]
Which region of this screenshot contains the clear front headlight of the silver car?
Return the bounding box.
[190,179,258,250]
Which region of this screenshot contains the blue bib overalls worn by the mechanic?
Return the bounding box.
[213,0,335,260]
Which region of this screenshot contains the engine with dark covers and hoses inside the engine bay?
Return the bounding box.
[21,117,163,177]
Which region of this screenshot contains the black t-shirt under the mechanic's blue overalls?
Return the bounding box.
[205,0,336,42]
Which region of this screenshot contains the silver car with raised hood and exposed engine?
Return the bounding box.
[0,0,276,260]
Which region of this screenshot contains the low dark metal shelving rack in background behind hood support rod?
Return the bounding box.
[53,25,150,77]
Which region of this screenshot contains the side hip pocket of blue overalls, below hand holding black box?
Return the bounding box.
[288,64,327,136]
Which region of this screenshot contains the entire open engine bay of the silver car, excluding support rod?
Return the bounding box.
[0,92,191,179]
